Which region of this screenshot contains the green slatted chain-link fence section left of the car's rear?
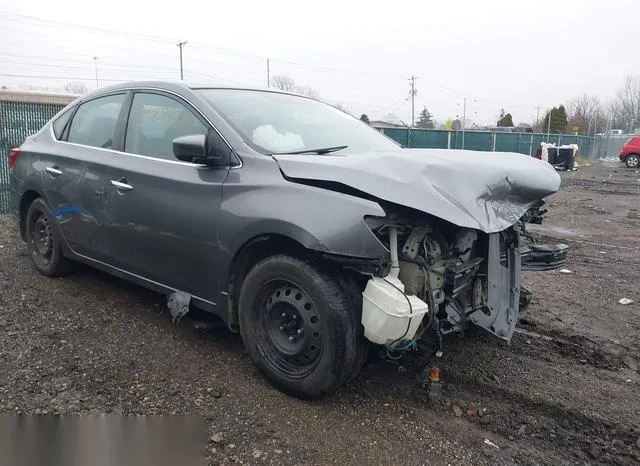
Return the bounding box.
[0,101,64,215]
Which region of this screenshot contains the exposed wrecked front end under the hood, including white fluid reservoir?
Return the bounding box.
[362,204,568,351]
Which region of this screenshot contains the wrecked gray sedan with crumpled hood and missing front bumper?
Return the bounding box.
[10,82,567,398]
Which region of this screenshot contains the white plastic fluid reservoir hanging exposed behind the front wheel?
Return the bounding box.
[362,275,429,345]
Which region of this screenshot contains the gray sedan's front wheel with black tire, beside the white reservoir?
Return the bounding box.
[239,255,366,399]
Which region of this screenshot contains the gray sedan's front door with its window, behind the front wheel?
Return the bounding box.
[108,91,229,302]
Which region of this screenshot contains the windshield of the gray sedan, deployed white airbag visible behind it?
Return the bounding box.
[196,89,400,155]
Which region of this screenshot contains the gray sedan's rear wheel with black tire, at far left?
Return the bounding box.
[25,198,73,277]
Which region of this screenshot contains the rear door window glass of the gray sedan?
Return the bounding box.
[68,94,125,149]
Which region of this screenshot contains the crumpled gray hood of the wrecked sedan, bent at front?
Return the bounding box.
[273,149,560,233]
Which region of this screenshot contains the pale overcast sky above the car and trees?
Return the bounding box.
[0,0,640,124]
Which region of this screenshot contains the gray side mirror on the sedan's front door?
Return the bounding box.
[173,131,231,167]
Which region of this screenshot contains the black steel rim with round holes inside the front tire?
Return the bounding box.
[266,286,322,366]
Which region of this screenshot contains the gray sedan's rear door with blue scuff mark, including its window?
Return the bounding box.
[40,92,127,260]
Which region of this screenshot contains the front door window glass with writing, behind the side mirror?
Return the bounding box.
[124,93,207,161]
